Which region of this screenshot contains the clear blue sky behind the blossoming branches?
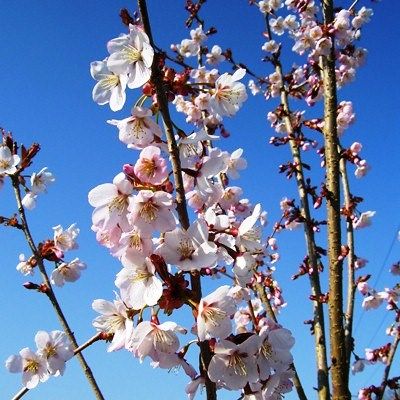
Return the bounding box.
[0,0,400,400]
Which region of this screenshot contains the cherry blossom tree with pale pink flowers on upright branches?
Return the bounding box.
[0,0,400,400]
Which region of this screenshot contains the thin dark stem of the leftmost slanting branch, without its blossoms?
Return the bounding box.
[10,175,104,400]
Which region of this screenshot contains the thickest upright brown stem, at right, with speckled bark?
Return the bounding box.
[322,0,351,400]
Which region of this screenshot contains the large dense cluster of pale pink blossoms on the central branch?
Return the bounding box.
[88,10,294,398]
